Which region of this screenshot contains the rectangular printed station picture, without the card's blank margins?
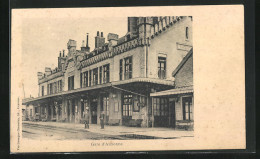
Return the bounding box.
[22,16,194,140]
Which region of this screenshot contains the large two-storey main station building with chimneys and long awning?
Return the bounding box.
[23,16,192,127]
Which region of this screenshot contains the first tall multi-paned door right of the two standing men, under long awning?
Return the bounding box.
[122,94,133,125]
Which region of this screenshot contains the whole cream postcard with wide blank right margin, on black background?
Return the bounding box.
[10,6,245,152]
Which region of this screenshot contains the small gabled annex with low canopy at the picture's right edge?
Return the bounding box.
[150,49,194,130]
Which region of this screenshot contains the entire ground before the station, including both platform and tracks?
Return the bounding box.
[23,121,193,140]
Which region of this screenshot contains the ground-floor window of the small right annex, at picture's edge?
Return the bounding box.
[182,97,193,120]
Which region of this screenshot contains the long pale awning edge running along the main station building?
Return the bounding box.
[22,78,174,104]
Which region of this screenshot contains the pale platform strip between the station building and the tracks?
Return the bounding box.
[23,121,193,138]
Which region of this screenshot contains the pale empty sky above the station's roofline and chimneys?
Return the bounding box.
[21,16,127,97]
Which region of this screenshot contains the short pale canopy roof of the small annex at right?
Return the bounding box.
[150,86,193,97]
